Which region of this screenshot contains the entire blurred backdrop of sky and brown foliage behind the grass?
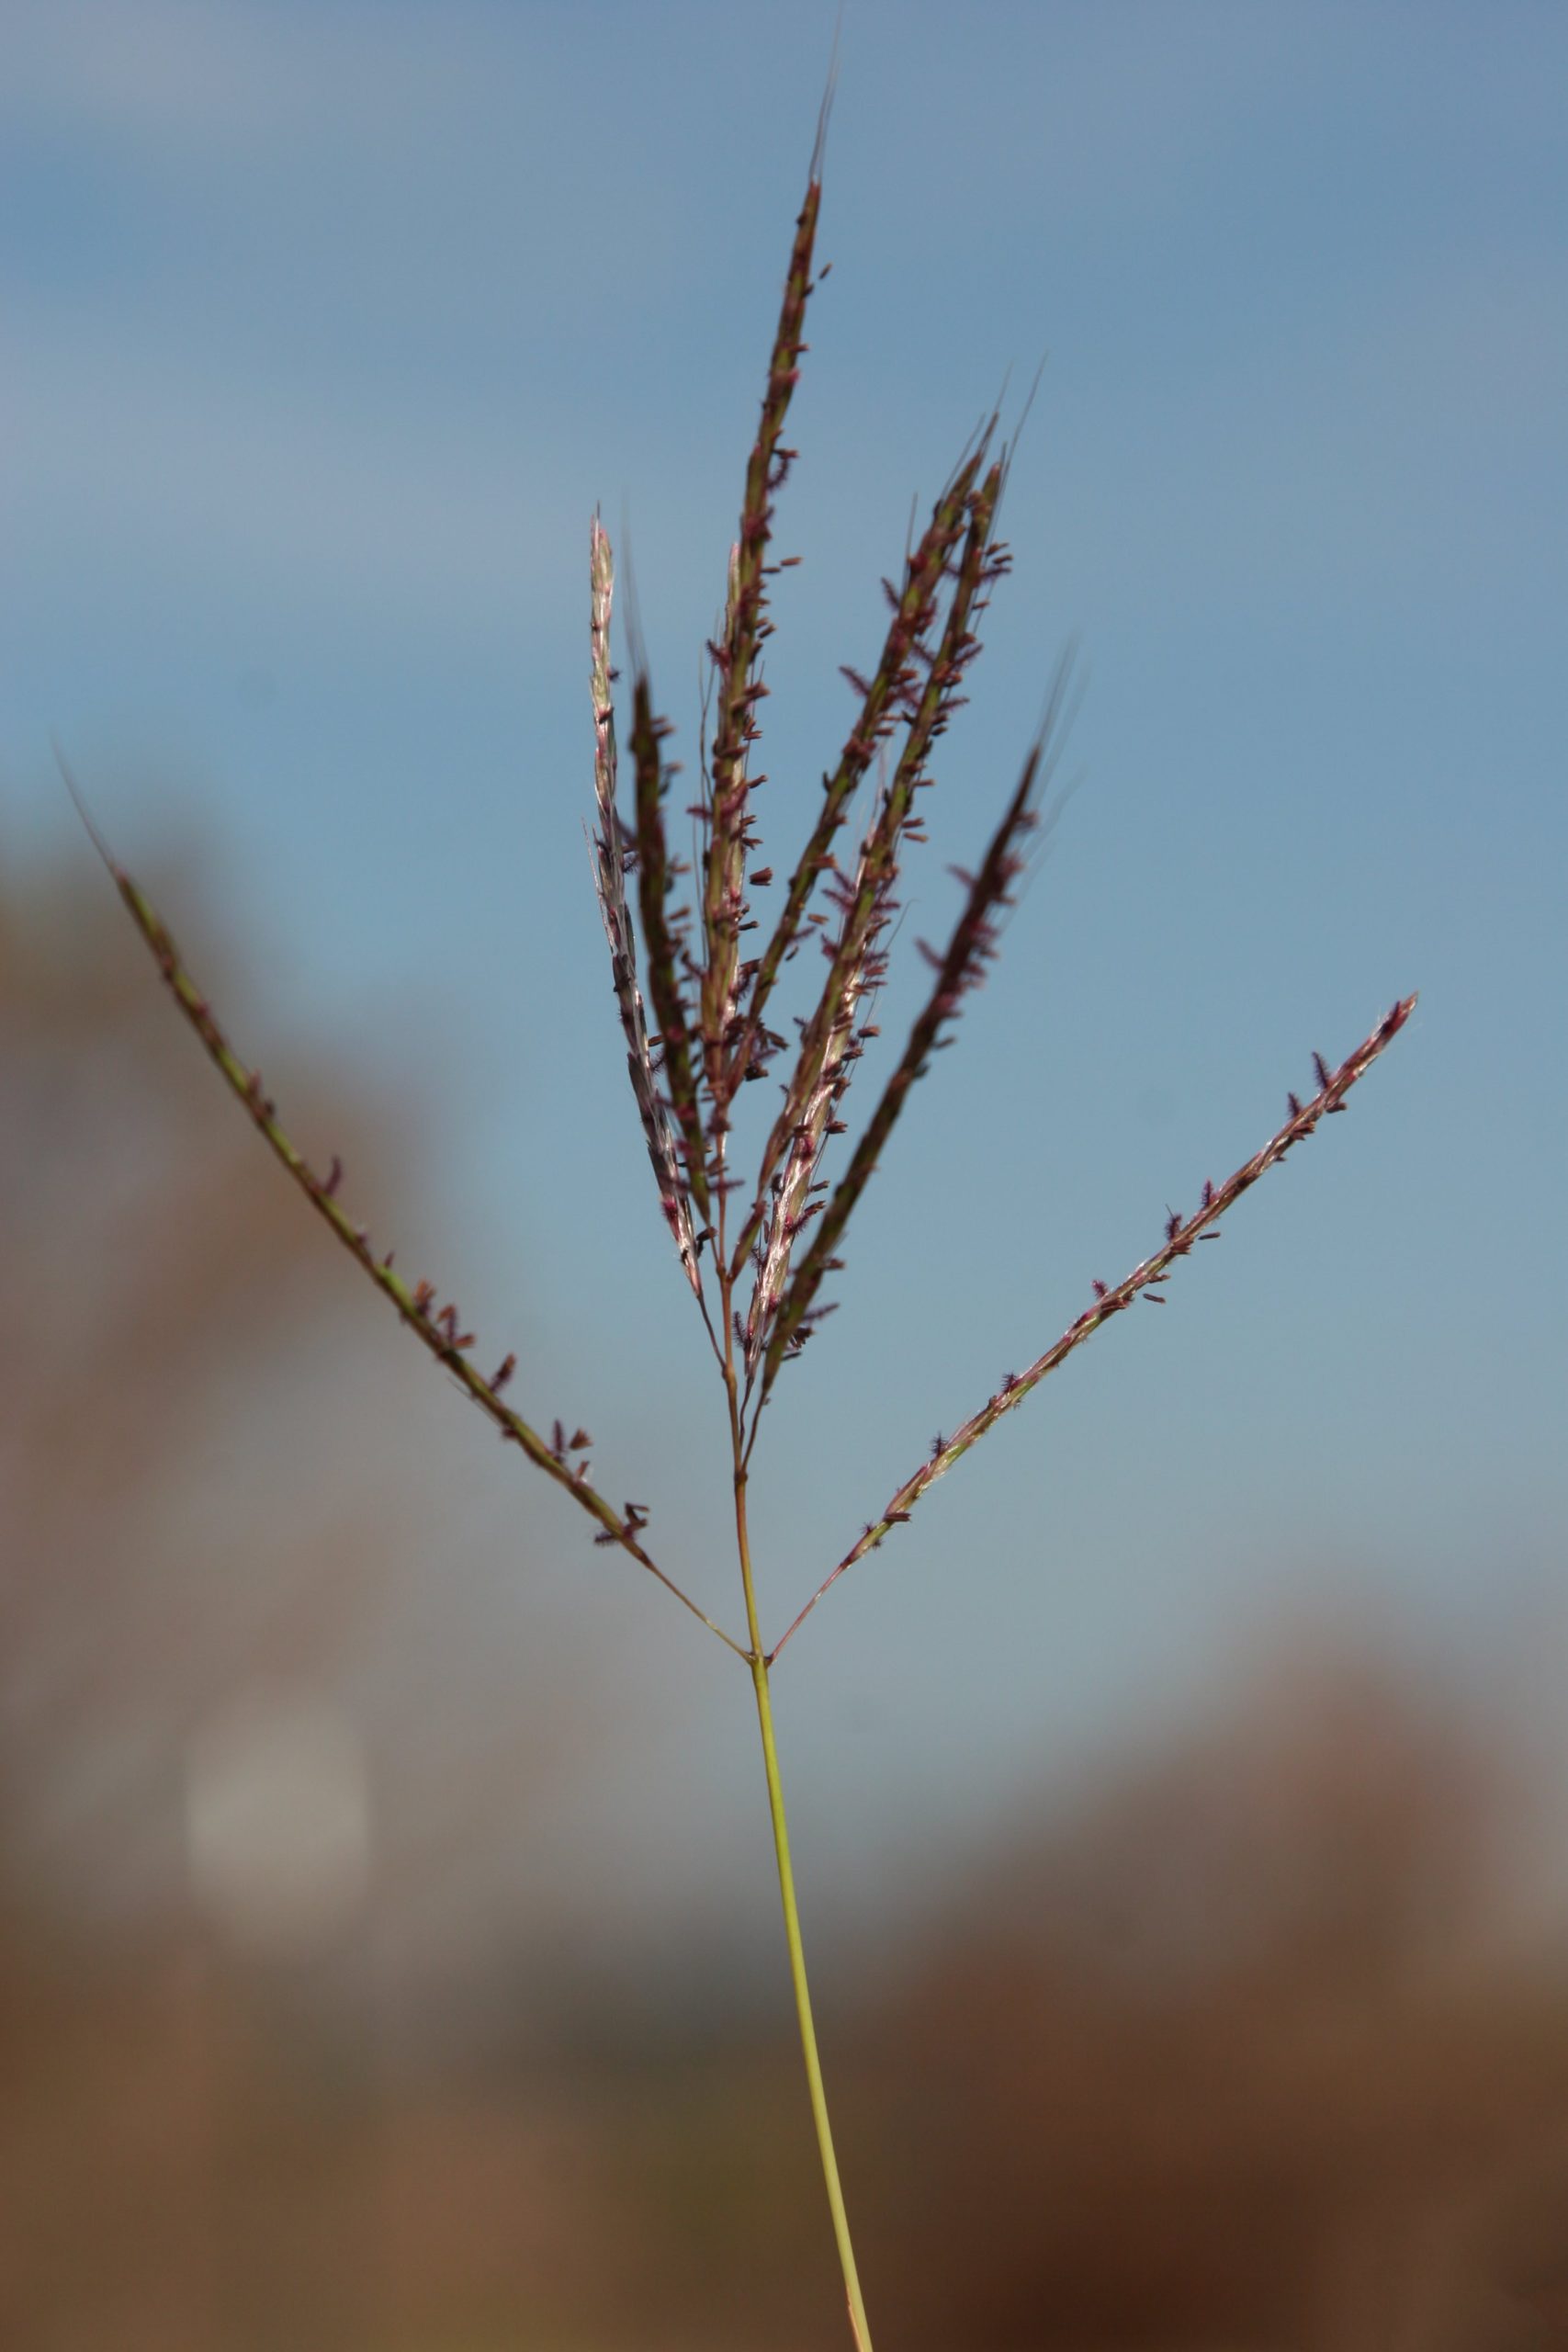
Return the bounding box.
[0,0,1568,2352]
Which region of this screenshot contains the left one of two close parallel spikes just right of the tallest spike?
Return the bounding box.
[731,439,995,1087]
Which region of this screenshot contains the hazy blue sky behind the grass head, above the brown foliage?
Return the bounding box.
[0,0,1568,1947]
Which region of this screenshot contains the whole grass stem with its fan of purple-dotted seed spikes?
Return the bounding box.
[66,114,1416,2352]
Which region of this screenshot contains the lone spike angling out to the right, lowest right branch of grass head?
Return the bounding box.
[766,995,1416,1665]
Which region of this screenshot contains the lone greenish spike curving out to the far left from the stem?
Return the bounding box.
[66,778,748,1658]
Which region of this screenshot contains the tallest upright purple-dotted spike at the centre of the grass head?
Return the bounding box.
[701,165,823,1105]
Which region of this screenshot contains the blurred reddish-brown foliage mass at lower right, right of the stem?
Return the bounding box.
[860,1651,1568,2352]
